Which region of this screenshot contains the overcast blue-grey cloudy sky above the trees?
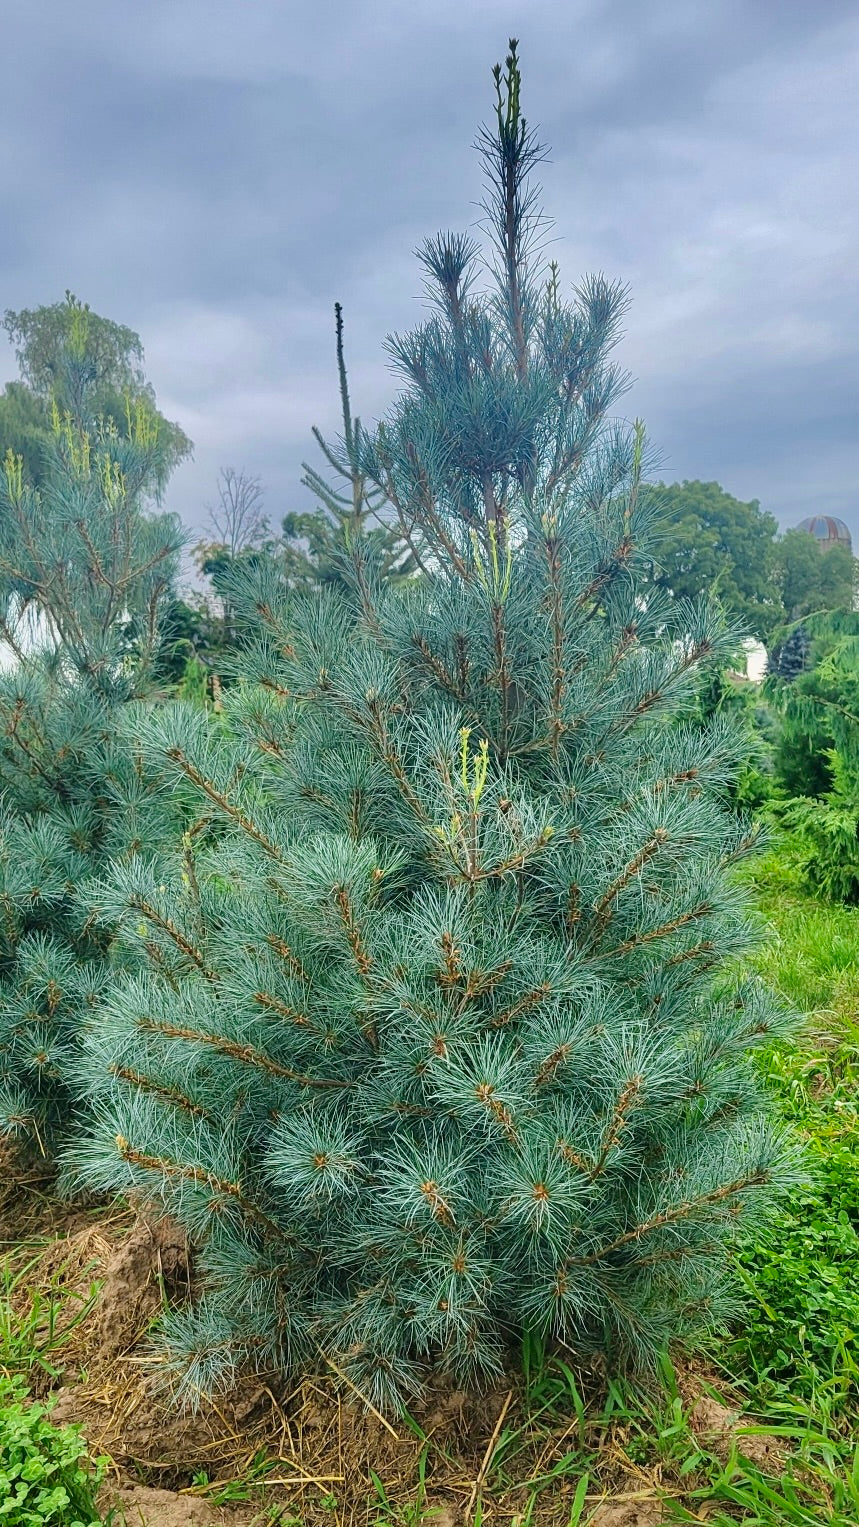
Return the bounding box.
[0,0,859,541]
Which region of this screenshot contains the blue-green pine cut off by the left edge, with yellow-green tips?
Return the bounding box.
[0,334,182,1148]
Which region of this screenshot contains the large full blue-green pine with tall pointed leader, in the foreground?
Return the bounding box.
[67,44,796,1405]
